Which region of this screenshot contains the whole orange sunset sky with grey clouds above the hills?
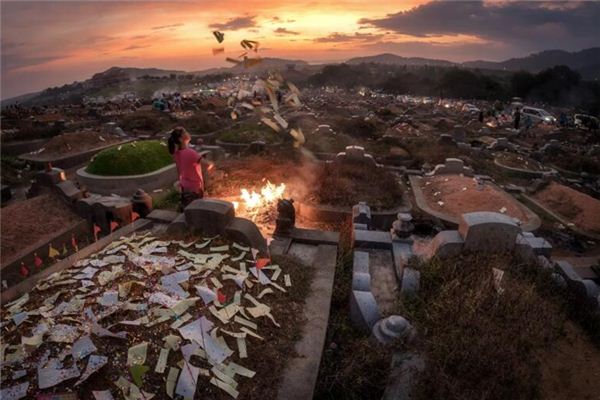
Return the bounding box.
[1,0,600,98]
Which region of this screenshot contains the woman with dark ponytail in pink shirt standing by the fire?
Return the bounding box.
[168,127,204,210]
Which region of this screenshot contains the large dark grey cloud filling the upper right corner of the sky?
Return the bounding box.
[359,1,600,48]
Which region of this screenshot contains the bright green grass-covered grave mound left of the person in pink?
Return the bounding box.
[86,140,173,176]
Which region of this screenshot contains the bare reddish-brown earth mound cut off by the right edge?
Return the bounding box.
[533,182,600,232]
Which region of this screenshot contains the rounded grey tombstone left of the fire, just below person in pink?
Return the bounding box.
[184,199,235,235]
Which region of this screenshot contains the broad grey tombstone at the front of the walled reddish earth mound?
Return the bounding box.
[458,211,521,253]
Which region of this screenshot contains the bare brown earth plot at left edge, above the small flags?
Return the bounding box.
[0,195,82,264]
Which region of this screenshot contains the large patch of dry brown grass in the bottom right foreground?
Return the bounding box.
[404,255,593,399]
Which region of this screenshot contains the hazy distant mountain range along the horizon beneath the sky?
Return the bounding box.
[2,47,600,106]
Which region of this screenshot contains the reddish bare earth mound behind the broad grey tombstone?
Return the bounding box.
[421,175,527,222]
